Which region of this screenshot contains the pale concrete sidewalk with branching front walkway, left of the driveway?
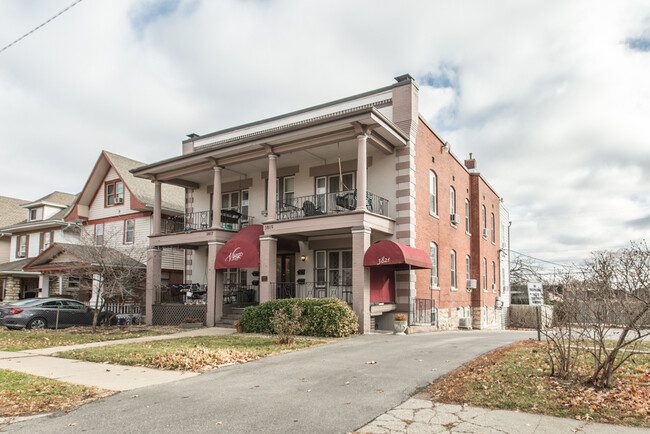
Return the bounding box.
[0,327,236,391]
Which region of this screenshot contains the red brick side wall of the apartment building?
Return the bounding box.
[415,120,499,309]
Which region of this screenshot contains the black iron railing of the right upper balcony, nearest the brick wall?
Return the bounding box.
[277,190,388,220]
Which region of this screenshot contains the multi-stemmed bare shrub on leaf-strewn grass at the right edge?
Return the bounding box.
[544,241,650,387]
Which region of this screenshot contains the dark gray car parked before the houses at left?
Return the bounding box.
[0,297,116,329]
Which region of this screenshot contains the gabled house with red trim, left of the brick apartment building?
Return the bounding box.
[23,151,185,303]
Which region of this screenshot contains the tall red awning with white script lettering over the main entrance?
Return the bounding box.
[214,225,264,270]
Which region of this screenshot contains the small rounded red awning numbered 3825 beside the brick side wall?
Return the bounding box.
[363,240,432,270]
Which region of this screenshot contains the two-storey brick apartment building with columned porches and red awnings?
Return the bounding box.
[132,74,501,332]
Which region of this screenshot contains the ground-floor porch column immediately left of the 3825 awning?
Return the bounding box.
[352,226,370,333]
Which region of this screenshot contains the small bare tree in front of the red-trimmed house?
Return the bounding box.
[68,229,146,331]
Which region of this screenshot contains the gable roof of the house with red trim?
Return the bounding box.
[70,151,185,219]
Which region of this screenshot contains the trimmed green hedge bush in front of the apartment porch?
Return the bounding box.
[241,298,359,337]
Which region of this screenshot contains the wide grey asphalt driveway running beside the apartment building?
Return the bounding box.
[0,331,534,433]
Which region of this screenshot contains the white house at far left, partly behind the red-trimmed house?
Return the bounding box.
[0,191,79,301]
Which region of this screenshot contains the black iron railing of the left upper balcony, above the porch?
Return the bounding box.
[160,209,253,234]
